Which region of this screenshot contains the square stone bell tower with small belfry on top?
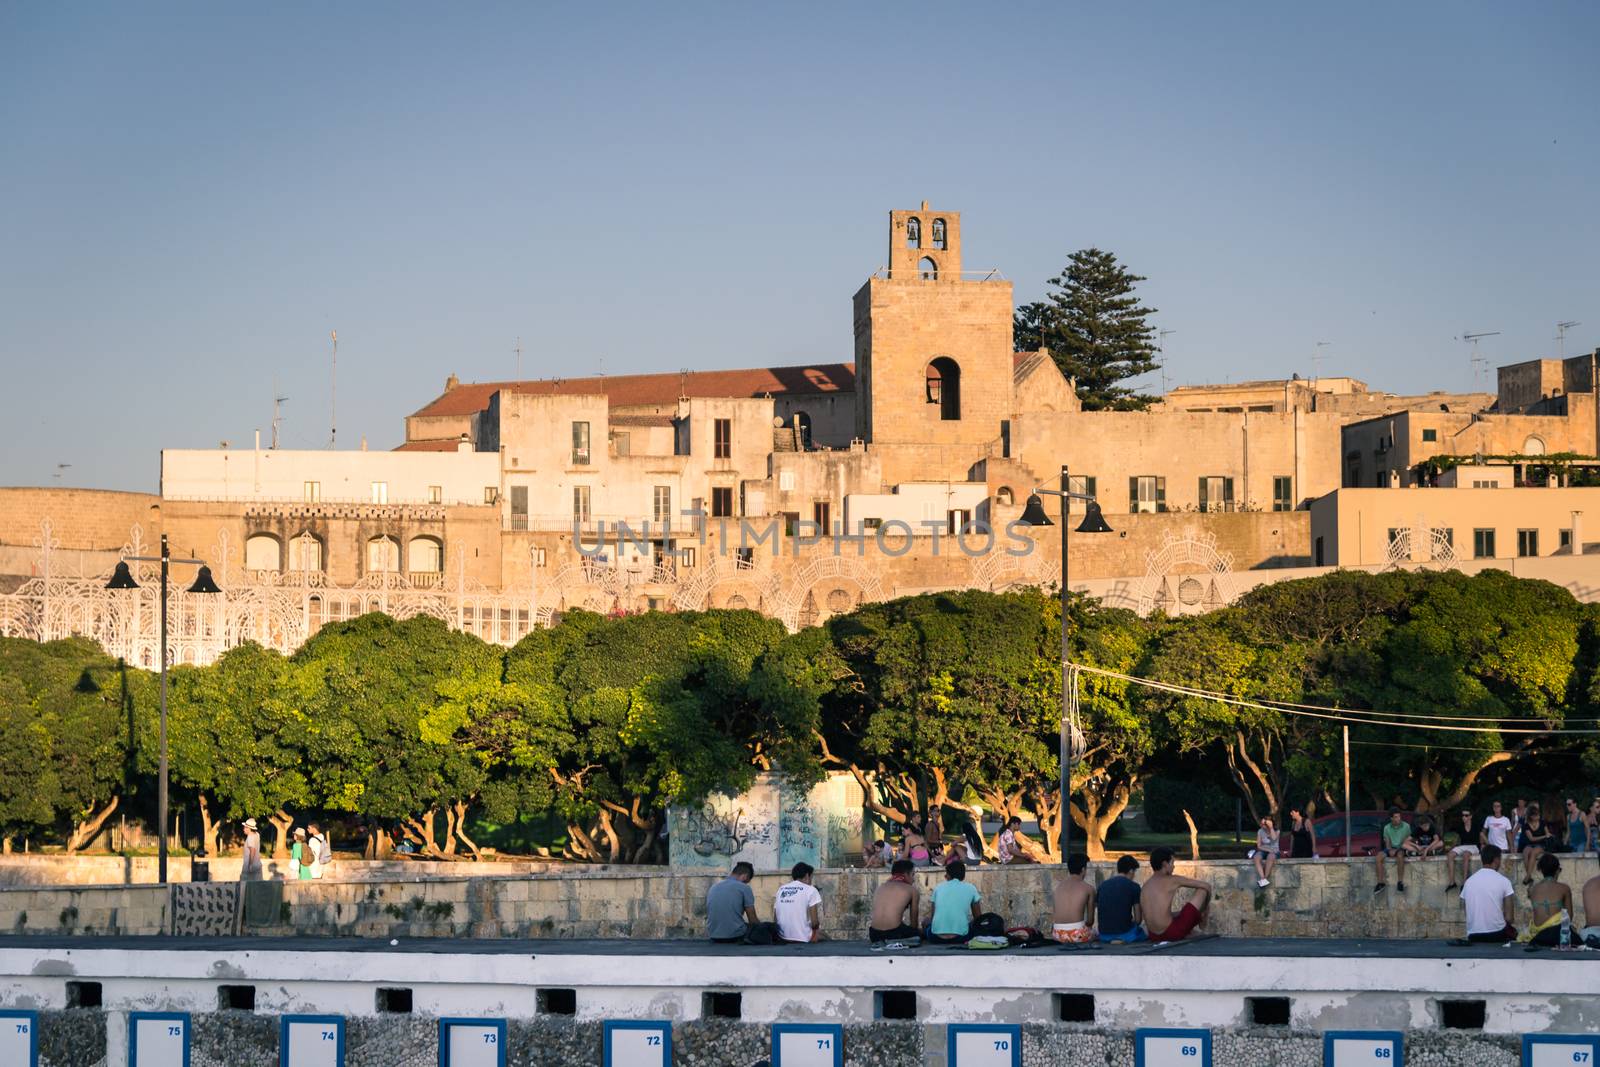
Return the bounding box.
[854,200,1013,480]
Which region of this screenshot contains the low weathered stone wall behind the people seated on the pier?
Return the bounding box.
[0,856,1600,939]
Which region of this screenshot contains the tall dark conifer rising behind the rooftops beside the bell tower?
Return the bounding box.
[1014,248,1157,411]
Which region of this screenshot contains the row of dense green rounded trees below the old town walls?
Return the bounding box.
[0,571,1600,862]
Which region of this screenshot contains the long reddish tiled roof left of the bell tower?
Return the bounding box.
[413,363,856,418]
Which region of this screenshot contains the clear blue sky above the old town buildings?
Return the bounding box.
[0,0,1600,490]
